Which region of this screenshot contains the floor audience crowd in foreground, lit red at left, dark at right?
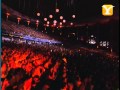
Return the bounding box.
[1,42,119,90]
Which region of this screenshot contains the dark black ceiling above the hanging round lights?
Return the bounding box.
[2,0,119,23]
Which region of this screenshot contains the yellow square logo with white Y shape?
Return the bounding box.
[102,4,114,16]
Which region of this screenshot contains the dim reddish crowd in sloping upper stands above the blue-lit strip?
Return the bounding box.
[2,19,57,40]
